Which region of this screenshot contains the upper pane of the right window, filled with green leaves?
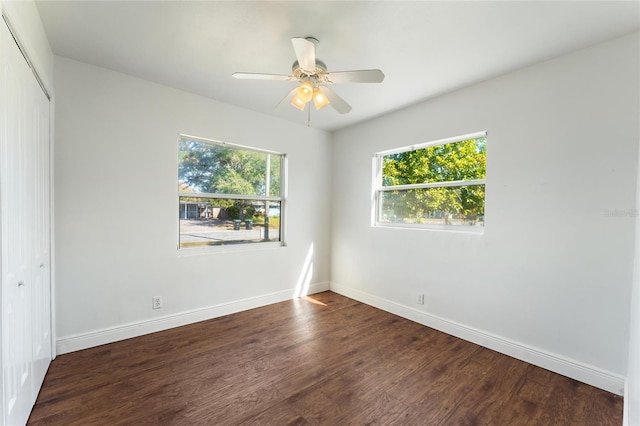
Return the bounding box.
[382,137,487,186]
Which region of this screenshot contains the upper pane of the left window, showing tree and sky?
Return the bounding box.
[178,139,281,196]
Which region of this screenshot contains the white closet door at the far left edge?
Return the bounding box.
[0,18,33,425]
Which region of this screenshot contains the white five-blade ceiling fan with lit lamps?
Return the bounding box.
[233,37,384,114]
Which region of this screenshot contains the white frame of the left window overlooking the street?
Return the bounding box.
[176,133,288,251]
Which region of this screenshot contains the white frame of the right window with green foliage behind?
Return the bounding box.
[371,131,487,233]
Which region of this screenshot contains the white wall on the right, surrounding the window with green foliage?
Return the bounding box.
[331,34,640,393]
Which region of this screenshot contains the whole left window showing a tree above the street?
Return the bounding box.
[178,135,286,249]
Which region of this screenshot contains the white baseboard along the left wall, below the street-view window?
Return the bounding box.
[56,282,329,355]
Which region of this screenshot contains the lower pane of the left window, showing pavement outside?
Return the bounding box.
[178,197,281,248]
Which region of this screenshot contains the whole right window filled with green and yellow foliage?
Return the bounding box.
[373,132,487,232]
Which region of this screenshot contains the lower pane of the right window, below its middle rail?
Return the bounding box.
[378,185,484,226]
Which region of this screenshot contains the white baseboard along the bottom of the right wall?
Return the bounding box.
[330,282,625,395]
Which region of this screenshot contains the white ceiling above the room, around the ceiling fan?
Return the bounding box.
[37,0,640,130]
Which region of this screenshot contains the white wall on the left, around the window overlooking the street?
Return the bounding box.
[55,57,331,353]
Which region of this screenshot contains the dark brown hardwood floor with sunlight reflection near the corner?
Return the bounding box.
[28,292,623,426]
